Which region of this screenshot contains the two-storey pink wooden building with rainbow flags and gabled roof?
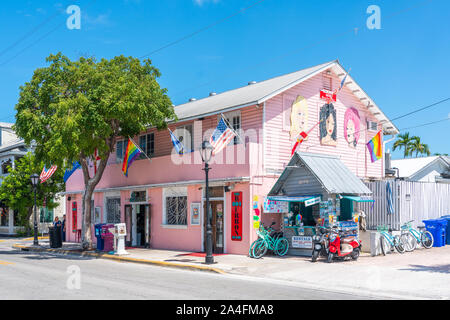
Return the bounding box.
[66,61,398,254]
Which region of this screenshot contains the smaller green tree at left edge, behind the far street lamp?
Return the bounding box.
[0,153,64,230]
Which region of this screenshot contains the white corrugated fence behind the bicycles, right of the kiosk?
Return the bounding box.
[359,180,450,230]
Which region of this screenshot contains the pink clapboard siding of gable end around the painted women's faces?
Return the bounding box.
[265,70,384,178]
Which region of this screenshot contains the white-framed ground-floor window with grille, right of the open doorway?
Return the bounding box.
[163,188,188,226]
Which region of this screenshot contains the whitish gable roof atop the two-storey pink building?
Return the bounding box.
[175,60,398,134]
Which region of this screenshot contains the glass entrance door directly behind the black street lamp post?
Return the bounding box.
[203,200,224,253]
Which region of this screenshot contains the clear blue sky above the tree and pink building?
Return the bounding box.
[0,0,450,158]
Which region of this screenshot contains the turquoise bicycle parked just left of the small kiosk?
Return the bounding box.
[249,222,289,259]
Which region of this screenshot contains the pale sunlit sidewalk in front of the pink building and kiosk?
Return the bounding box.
[14,242,450,299]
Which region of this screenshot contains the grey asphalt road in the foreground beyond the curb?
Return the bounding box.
[0,239,384,300]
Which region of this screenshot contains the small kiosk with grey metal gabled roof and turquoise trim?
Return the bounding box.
[264,152,373,256]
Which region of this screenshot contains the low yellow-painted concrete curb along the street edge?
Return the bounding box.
[12,244,226,274]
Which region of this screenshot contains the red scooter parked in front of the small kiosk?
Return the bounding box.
[327,228,361,263]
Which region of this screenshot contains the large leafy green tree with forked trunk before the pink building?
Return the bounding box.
[15,53,176,248]
